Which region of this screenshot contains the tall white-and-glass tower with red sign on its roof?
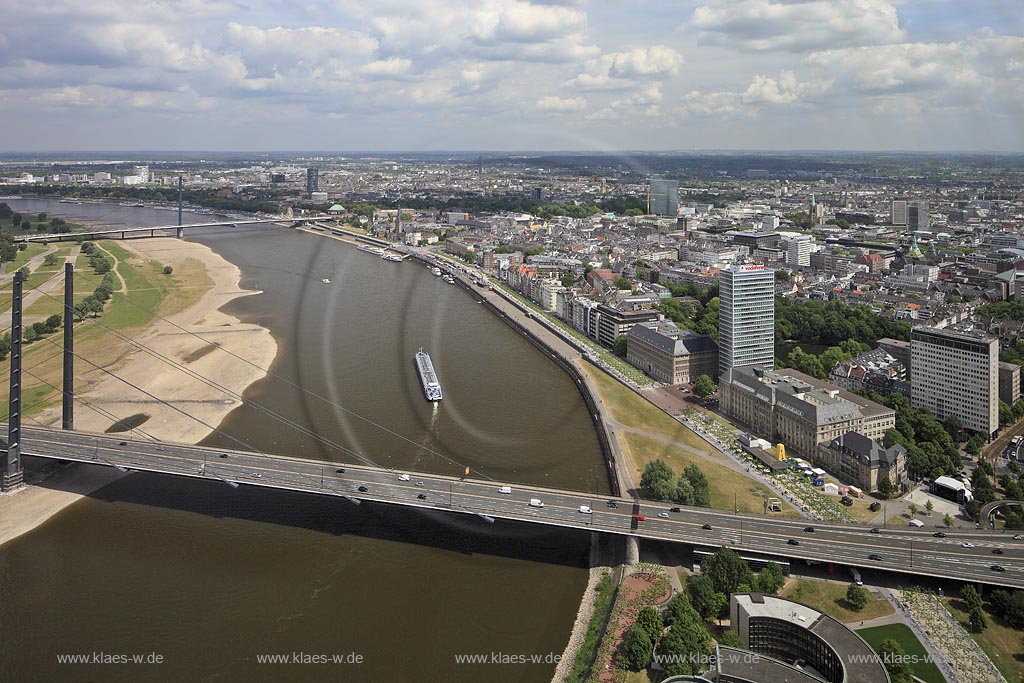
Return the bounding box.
[718,263,775,377]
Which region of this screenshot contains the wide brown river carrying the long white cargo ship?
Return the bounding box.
[0,200,607,681]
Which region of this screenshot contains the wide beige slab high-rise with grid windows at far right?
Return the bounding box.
[910,328,999,436]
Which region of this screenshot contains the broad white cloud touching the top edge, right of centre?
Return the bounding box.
[684,0,906,52]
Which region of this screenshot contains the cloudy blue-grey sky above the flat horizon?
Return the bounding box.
[0,0,1024,152]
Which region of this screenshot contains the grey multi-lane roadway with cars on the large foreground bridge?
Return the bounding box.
[14,425,1024,588]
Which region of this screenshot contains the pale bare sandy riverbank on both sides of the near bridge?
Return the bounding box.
[0,238,278,544]
